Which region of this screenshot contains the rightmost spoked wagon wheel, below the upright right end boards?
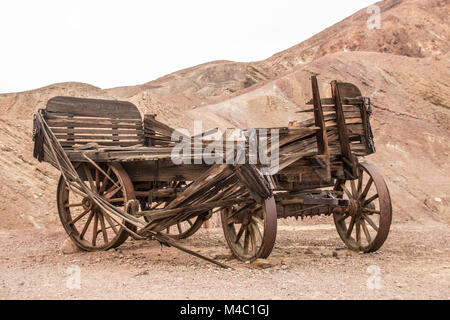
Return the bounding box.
[333,163,392,252]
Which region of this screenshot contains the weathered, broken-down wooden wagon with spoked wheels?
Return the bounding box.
[34,77,392,261]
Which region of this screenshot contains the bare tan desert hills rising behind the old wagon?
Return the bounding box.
[0,0,450,229]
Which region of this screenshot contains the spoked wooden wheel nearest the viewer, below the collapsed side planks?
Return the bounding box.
[220,197,277,261]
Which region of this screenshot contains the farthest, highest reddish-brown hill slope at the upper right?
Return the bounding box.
[256,0,450,75]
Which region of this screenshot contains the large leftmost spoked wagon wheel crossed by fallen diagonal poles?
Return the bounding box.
[57,163,136,251]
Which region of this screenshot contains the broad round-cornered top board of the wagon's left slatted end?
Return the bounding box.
[46,96,142,120]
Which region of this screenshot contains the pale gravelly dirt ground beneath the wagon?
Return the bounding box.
[0,219,450,299]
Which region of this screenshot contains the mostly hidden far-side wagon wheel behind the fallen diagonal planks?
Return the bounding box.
[144,181,205,239]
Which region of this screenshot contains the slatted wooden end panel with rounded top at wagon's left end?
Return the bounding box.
[46,96,144,148]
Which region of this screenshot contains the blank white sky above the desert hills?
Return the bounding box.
[0,0,376,93]
